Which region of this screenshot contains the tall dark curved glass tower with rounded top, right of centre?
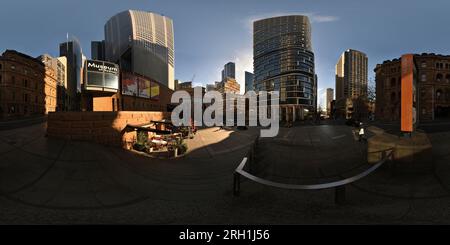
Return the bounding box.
[253,15,317,120]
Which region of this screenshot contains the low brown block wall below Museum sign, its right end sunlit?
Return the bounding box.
[47,111,170,147]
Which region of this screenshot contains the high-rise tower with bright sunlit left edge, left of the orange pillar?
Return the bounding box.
[336,49,367,101]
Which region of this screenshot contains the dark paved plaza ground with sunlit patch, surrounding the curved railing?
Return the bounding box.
[0,124,450,224]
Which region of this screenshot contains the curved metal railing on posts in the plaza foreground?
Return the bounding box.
[233,138,394,204]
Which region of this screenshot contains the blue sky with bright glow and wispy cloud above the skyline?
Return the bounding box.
[0,0,450,106]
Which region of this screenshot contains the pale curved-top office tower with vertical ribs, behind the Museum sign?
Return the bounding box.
[105,10,175,89]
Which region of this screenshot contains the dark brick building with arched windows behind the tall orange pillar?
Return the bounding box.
[374,53,450,121]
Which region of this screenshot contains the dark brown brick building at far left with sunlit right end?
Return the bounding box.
[0,50,57,120]
